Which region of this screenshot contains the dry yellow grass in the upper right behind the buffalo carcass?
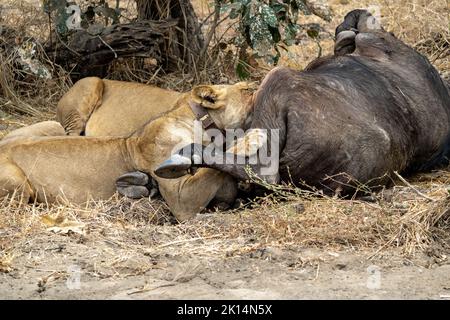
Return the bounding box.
[281,0,450,73]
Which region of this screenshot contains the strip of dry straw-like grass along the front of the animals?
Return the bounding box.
[0,171,450,270]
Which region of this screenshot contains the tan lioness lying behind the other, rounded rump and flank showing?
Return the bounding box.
[56,77,182,137]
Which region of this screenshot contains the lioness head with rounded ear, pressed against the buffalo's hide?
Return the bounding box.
[191,82,257,129]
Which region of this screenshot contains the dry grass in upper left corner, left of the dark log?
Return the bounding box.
[0,0,72,122]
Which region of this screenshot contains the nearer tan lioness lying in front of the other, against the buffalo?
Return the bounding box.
[0,83,252,220]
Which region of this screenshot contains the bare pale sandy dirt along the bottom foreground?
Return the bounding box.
[0,235,450,300]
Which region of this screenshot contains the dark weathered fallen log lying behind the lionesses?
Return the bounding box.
[45,19,178,80]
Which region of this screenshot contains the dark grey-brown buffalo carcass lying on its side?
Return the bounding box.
[156,10,450,194]
